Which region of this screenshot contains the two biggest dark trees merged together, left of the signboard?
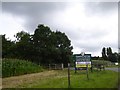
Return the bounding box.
[33,25,72,64]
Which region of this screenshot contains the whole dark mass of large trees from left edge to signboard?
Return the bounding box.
[2,24,73,66]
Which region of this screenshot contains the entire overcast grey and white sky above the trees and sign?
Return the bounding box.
[0,2,118,56]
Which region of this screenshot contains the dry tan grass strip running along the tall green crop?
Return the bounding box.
[2,70,57,88]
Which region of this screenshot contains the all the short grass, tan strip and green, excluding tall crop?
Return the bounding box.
[3,69,118,88]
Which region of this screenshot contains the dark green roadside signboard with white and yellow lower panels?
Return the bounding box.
[75,54,91,68]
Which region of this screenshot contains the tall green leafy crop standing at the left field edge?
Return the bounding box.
[2,59,43,77]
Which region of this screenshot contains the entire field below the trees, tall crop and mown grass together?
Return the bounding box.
[2,59,118,88]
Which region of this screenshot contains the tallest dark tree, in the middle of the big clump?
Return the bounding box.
[33,25,51,63]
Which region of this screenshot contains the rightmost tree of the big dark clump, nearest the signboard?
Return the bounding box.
[55,31,73,64]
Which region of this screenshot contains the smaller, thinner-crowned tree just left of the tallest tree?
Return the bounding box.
[14,31,33,59]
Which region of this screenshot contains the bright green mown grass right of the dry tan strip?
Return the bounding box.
[19,70,118,88]
